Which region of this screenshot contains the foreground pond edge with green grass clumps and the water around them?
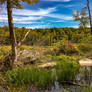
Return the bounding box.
[0,59,92,92]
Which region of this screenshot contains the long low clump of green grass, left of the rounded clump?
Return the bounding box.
[6,67,54,86]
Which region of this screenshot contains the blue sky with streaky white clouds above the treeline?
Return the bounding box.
[0,0,92,29]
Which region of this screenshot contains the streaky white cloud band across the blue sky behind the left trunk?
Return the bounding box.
[0,7,72,24]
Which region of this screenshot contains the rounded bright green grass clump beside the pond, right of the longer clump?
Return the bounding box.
[55,59,79,82]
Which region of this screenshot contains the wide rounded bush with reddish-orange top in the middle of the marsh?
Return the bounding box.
[45,40,80,55]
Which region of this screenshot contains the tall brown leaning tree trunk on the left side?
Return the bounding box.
[7,0,17,67]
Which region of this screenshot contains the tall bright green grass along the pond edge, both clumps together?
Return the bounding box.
[6,55,79,87]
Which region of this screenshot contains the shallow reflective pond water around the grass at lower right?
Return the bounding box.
[27,67,92,92]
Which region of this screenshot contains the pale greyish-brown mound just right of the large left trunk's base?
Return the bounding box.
[17,50,40,65]
